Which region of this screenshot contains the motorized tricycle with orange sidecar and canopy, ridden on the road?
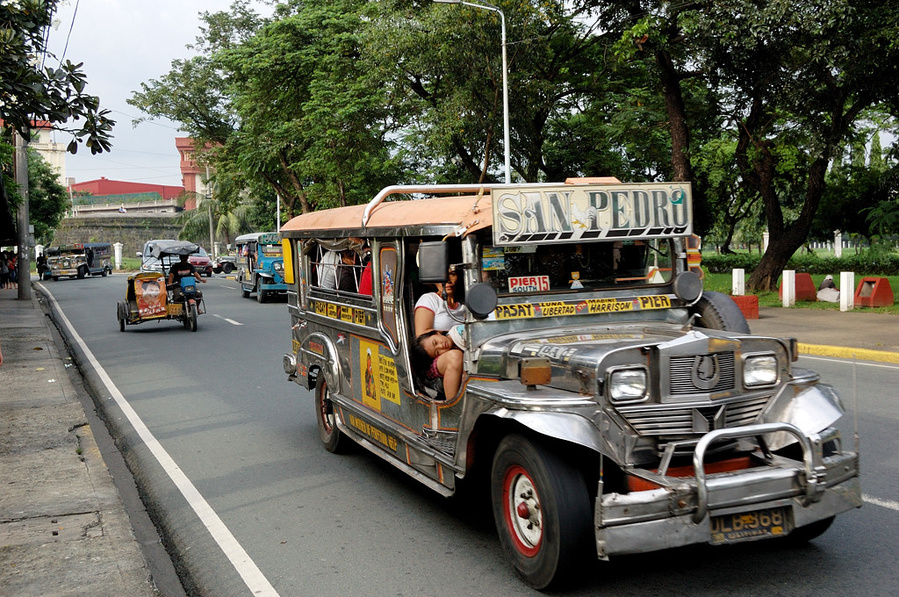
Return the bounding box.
[116,240,206,332]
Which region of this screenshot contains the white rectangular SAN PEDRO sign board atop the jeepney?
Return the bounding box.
[493,182,693,245]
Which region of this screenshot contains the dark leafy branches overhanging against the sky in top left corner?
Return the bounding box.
[0,0,115,154]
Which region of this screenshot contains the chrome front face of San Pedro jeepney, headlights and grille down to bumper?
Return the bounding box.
[595,330,861,557]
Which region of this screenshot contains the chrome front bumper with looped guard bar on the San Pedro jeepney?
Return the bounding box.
[595,423,862,559]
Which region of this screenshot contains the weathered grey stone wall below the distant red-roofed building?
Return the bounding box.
[50,214,181,257]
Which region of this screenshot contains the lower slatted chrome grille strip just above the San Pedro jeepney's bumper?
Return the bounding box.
[618,396,771,436]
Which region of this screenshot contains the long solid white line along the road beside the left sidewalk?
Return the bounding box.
[38,284,279,597]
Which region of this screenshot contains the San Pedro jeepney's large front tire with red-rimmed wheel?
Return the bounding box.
[490,435,593,590]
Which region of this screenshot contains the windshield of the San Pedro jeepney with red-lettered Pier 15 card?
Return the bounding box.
[480,239,674,295]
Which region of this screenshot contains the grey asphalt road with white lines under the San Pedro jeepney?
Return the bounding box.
[38,275,899,597]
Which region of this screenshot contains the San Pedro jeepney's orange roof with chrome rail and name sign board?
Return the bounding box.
[281,178,693,245]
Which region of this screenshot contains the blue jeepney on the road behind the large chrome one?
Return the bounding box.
[234,232,287,303]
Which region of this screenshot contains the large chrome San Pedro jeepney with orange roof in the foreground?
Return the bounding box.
[281,180,861,589]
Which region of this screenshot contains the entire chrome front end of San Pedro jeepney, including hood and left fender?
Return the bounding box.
[481,322,861,558]
